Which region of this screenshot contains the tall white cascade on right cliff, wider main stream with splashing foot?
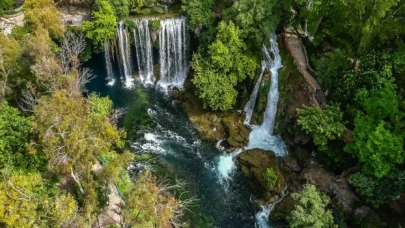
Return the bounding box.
[247,34,286,156]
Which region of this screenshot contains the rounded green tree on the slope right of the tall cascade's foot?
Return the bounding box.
[297,105,345,150]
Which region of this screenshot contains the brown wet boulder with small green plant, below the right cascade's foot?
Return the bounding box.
[237,150,285,194]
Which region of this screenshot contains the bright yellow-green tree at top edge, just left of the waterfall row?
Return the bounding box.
[82,0,117,47]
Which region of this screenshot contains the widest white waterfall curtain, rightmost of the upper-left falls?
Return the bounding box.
[158,17,188,89]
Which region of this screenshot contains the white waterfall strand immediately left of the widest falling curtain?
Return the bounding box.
[133,18,154,84]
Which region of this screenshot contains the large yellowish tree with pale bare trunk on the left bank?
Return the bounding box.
[33,92,123,220]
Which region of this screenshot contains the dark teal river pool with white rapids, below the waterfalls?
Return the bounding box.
[86,55,258,224]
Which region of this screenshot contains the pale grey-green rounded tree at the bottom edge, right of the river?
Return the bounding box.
[287,185,337,228]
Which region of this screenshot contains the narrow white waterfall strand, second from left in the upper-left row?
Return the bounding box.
[117,21,134,88]
